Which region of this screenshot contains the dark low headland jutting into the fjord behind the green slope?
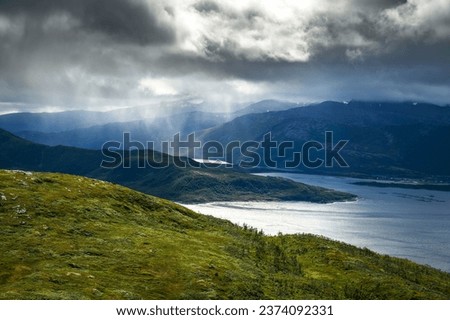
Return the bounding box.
[0,129,355,203]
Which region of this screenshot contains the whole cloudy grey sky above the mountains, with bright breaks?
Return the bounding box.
[0,0,450,113]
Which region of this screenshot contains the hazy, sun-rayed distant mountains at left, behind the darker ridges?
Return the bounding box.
[0,100,298,151]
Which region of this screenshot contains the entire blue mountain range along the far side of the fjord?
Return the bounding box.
[4,100,450,181]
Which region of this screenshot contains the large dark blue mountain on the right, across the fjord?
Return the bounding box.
[198,101,450,177]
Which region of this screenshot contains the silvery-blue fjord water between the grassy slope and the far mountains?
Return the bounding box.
[187,173,450,272]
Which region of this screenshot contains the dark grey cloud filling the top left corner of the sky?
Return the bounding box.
[0,0,175,45]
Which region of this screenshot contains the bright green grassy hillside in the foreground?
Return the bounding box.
[0,170,450,299]
